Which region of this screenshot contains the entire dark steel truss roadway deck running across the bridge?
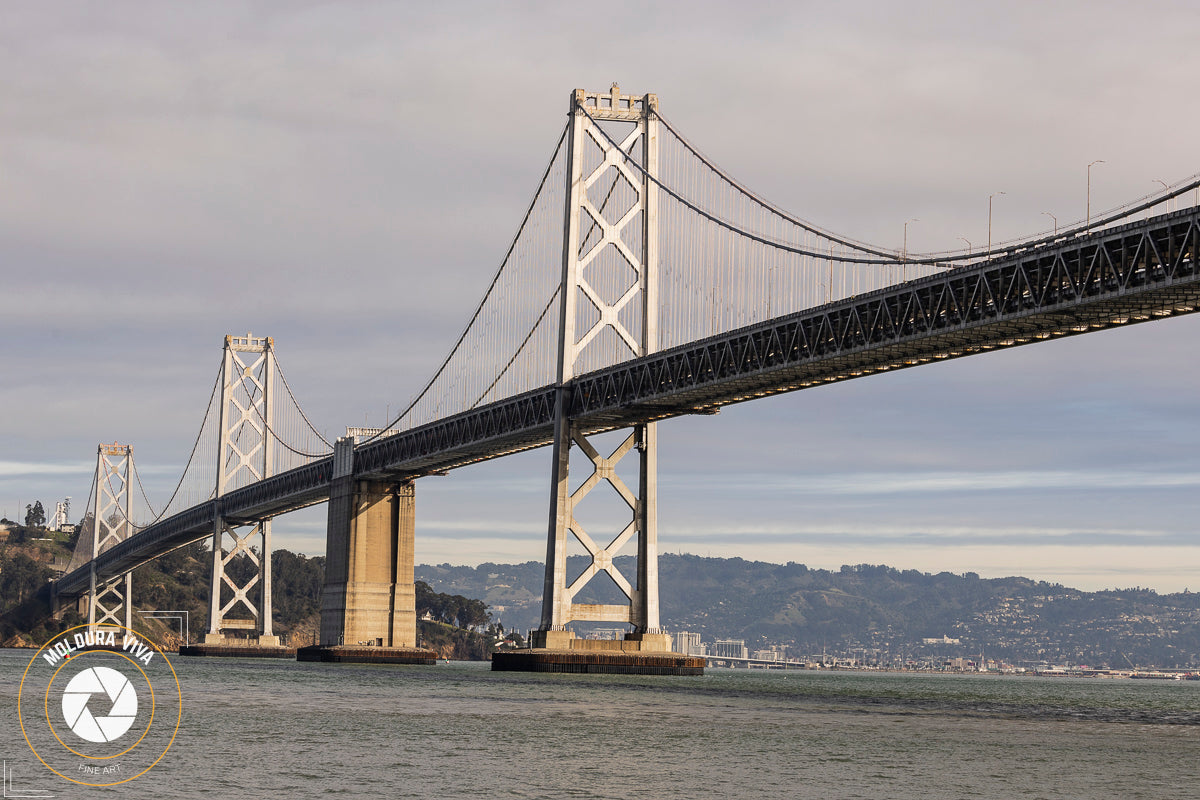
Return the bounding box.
[56,207,1200,596]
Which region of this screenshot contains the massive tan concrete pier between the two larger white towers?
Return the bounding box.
[298,437,437,663]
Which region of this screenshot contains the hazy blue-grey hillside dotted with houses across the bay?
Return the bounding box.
[416,554,1200,668]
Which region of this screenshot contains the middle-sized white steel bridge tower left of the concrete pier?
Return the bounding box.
[204,333,280,646]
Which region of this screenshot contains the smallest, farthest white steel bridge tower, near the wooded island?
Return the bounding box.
[88,441,134,627]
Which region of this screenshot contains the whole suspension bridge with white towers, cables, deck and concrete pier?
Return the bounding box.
[46,85,1200,671]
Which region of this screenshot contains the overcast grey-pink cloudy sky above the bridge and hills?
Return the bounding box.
[0,0,1200,591]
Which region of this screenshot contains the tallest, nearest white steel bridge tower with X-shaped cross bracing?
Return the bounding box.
[533,84,671,651]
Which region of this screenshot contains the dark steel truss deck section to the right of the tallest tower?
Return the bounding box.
[571,210,1200,428]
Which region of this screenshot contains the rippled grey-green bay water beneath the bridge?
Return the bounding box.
[0,650,1200,800]
